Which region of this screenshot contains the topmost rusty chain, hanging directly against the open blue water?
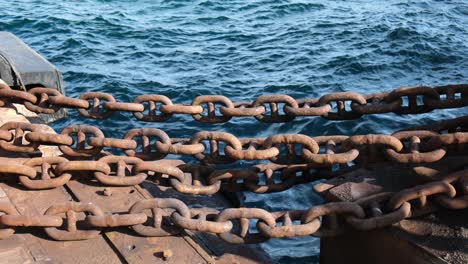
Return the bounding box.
[0,84,468,123]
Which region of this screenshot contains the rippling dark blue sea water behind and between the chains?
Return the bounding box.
[0,0,468,263]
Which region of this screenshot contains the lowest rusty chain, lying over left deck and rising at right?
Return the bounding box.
[0,170,468,243]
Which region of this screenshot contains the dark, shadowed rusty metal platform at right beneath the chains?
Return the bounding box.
[314,156,468,263]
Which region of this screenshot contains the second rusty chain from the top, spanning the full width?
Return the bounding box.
[0,122,468,165]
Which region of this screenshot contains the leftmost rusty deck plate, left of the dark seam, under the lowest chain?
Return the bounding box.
[0,183,120,263]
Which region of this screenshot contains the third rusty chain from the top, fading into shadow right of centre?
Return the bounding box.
[0,156,336,195]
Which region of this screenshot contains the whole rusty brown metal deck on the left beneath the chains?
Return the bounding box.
[0,106,269,263]
